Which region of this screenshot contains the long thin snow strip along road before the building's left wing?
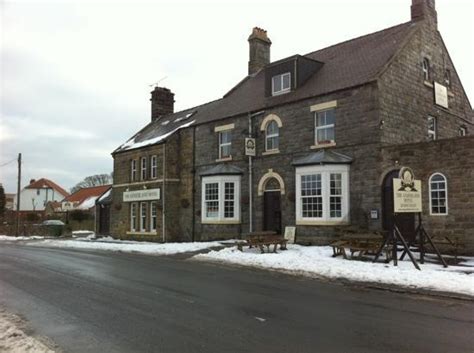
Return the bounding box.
[29,237,228,255]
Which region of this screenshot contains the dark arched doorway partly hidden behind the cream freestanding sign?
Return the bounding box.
[382,170,415,240]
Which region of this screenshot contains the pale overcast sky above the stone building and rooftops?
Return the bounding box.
[0,0,474,192]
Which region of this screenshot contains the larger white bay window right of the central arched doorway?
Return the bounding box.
[296,165,349,224]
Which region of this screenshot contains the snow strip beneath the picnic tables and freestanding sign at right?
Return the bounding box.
[193,245,474,296]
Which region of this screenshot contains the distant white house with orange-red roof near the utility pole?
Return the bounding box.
[14,178,69,212]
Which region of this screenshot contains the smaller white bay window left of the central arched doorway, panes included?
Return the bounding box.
[201,175,240,223]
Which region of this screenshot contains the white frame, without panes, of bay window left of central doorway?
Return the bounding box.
[201,175,241,224]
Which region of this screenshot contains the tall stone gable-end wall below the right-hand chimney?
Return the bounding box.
[378,21,474,144]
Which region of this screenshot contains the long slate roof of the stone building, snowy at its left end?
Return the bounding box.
[113,22,418,153]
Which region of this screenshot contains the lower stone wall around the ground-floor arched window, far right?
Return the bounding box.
[381,136,474,254]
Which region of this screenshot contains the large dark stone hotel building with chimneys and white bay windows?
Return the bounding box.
[111,0,474,250]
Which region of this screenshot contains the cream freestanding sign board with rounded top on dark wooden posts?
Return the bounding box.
[393,167,422,213]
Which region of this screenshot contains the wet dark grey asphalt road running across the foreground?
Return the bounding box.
[0,244,474,353]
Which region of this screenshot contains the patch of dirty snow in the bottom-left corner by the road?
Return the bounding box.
[0,310,54,353]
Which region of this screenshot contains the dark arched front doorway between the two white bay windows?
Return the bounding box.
[263,178,281,234]
